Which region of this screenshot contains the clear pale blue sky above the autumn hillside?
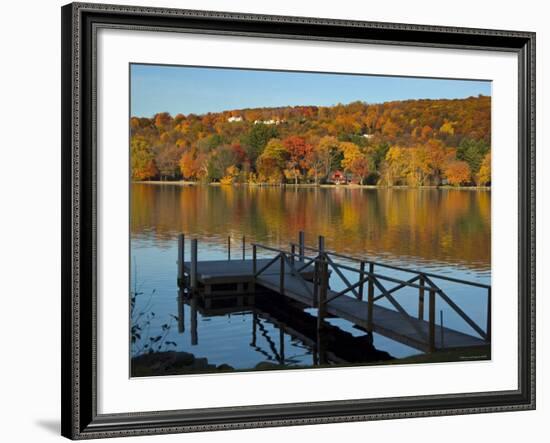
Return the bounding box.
[130,64,491,117]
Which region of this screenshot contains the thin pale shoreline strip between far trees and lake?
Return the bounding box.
[134,180,491,191]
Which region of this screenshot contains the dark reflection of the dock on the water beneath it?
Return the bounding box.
[178,291,392,366]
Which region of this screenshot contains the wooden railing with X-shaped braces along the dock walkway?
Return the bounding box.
[252,236,491,350]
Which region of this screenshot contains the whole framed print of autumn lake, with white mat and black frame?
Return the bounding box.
[62,3,535,439]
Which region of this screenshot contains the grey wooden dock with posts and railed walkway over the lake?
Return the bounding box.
[178,233,491,352]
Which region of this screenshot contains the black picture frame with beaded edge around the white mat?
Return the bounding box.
[61,3,535,439]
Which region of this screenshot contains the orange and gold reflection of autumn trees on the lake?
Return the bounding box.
[131,184,491,269]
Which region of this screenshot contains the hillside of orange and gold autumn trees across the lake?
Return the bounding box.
[130,96,491,186]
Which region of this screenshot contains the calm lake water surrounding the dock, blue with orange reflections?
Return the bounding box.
[131,184,491,370]
